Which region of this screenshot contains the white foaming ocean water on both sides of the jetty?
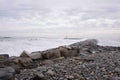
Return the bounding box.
[0,37,120,56]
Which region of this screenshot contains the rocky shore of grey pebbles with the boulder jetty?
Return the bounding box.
[0,39,120,80]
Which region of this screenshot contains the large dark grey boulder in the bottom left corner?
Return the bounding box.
[0,67,15,80]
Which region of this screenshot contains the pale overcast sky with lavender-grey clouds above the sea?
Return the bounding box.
[0,0,120,38]
